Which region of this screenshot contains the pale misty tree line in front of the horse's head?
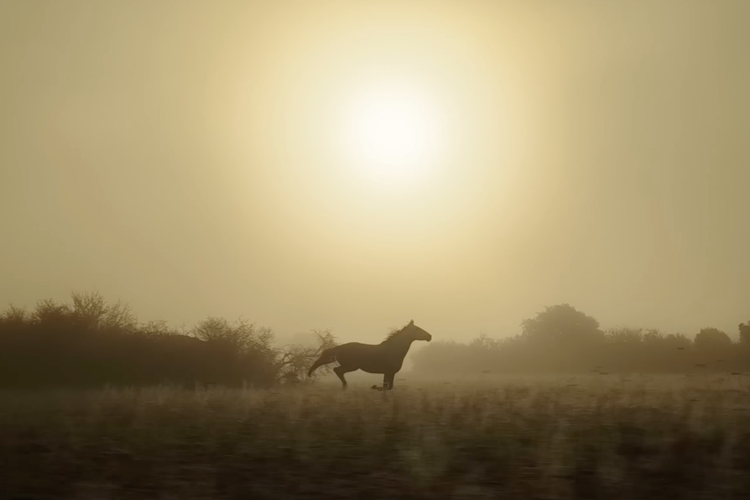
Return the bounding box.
[412,304,750,374]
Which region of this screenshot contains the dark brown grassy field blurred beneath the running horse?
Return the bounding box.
[0,375,750,500]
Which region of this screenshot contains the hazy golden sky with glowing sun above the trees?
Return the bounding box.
[0,0,750,341]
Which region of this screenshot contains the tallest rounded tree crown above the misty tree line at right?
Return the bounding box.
[521,304,604,344]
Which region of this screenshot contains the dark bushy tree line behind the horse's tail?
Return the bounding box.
[0,292,335,388]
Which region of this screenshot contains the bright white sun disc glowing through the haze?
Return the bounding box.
[345,84,442,182]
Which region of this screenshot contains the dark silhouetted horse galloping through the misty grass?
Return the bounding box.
[307,320,432,391]
